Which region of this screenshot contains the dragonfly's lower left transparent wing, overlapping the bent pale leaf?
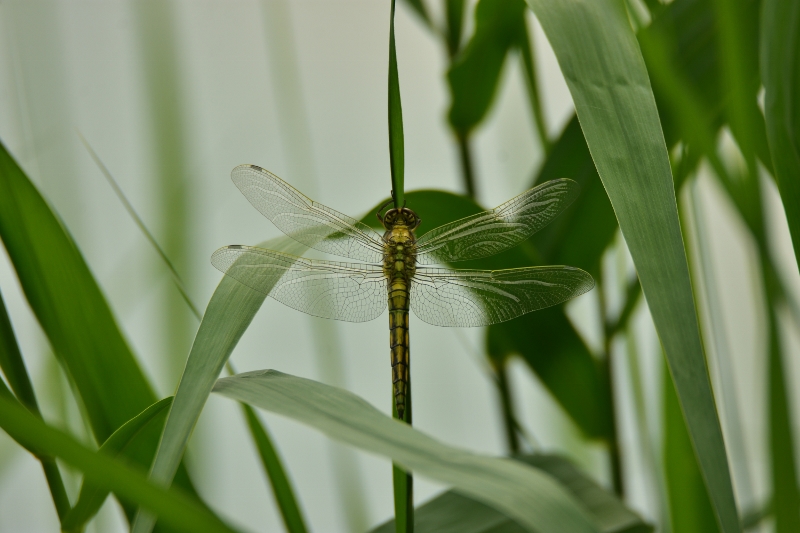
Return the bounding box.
[211,246,388,322]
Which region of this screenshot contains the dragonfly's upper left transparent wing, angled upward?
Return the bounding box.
[231,165,383,263]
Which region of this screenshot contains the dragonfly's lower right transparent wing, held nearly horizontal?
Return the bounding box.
[411,266,594,327]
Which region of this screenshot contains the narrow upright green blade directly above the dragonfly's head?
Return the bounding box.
[389,0,405,207]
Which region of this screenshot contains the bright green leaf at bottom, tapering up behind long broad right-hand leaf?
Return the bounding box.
[664,366,719,533]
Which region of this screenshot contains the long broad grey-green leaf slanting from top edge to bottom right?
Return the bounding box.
[530,0,740,533]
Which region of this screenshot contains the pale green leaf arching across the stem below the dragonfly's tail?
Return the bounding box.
[214,370,598,533]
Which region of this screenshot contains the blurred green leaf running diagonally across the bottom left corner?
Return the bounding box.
[0,390,239,533]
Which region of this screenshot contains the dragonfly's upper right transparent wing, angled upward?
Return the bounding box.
[417,179,580,265]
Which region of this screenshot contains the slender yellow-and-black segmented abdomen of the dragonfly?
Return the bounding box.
[389,278,409,419]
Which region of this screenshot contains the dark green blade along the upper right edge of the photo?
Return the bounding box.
[761,0,800,276]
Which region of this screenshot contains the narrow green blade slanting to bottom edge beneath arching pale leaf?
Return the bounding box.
[240,403,306,533]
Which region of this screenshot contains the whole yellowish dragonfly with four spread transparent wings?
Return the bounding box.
[211,165,594,419]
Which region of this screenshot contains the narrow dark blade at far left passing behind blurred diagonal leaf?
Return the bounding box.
[0,286,70,520]
